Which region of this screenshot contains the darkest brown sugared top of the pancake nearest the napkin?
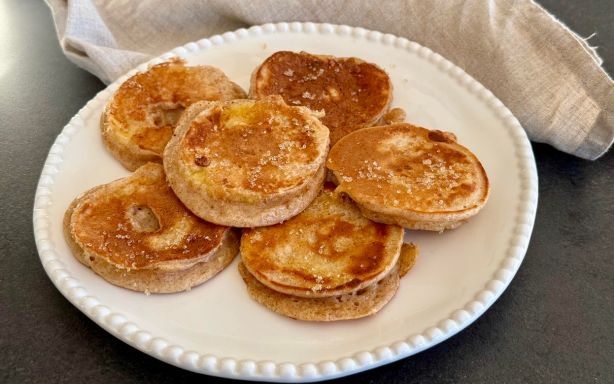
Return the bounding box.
[250,51,392,144]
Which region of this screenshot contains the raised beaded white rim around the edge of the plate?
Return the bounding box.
[33,22,537,382]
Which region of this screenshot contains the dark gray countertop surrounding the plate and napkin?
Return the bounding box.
[0,0,614,383]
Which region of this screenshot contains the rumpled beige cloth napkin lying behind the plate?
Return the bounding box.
[47,0,614,159]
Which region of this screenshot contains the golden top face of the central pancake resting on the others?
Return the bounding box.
[179,97,328,200]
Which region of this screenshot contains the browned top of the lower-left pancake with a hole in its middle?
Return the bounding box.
[69,163,229,269]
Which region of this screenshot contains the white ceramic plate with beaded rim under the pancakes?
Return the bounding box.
[34,23,537,382]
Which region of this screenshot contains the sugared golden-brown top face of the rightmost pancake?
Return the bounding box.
[327,123,489,213]
